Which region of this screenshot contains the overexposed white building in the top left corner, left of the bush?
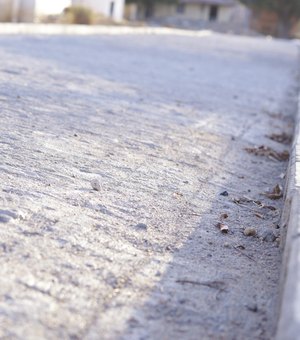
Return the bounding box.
[0,0,71,22]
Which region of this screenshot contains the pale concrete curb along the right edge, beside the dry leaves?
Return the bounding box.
[276,92,300,340]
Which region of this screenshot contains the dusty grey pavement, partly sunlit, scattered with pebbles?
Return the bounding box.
[0,34,298,339]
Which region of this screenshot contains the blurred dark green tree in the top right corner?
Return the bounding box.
[240,0,300,38]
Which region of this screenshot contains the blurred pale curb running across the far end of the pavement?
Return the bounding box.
[0,23,212,37]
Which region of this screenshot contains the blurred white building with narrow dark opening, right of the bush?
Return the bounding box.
[72,0,125,21]
